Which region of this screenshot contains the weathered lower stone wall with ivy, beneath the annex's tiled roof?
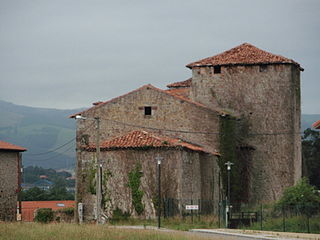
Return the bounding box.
[78,148,218,221]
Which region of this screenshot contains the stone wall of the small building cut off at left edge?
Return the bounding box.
[0,151,19,221]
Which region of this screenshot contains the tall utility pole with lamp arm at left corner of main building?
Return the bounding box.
[76,115,102,224]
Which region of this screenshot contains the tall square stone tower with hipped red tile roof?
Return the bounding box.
[187,43,303,202]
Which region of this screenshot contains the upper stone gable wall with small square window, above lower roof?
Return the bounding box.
[77,86,219,154]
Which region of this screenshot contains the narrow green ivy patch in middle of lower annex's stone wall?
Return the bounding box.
[128,163,144,215]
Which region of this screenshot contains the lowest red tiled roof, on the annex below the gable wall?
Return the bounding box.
[86,130,219,155]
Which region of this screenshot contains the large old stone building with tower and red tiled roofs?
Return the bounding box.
[71,43,303,221]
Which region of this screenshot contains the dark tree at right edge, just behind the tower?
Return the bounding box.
[302,128,320,189]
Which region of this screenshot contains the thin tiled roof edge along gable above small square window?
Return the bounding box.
[69,84,225,118]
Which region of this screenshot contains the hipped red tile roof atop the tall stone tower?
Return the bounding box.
[186,43,303,71]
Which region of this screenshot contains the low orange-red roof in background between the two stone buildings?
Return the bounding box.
[21,200,75,222]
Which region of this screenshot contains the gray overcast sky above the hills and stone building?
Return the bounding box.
[0,0,320,113]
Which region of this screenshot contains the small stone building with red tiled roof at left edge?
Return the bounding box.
[0,141,27,221]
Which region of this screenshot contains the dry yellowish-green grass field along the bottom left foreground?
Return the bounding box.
[0,223,208,240]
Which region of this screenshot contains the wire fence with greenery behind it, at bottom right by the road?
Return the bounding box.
[161,198,320,233]
